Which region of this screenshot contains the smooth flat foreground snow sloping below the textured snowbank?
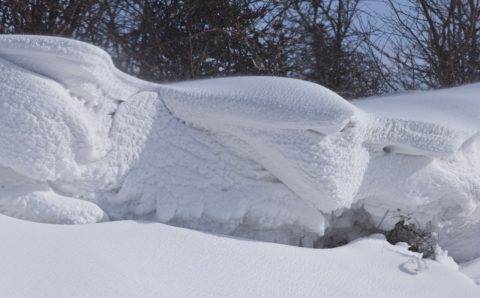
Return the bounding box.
[0,216,480,297]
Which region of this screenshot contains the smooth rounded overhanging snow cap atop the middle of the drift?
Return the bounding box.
[162,76,355,134]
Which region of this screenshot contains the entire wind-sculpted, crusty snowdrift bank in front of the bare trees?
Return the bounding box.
[0,35,480,261]
